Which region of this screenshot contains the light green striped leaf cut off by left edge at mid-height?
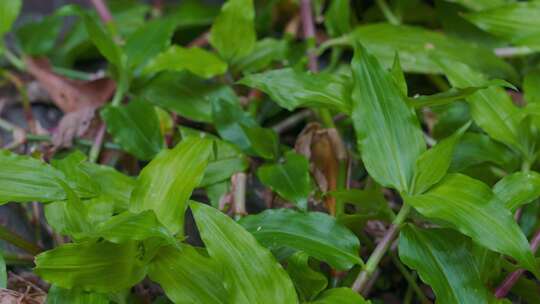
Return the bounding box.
[0,150,66,204]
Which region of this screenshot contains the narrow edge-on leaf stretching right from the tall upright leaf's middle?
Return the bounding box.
[409,79,517,108]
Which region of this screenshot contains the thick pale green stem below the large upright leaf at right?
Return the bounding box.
[352,204,411,293]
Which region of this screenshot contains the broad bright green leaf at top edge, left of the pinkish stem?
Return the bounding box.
[209,0,257,61]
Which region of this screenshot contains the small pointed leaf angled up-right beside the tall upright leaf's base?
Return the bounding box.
[413,123,470,194]
